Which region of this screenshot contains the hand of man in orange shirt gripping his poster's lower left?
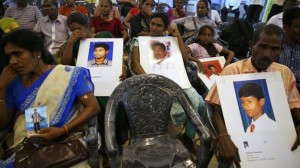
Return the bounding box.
[216,136,241,168]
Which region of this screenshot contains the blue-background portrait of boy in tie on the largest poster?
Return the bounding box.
[233,79,277,133]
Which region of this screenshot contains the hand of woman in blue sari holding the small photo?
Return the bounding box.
[31,127,66,141]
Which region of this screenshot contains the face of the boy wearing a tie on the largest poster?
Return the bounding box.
[240,96,265,120]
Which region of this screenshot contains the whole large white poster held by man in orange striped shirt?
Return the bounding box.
[216,72,300,168]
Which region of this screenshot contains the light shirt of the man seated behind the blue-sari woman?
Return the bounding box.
[34,14,69,54]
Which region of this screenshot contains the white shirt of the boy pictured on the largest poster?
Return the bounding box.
[246,113,277,133]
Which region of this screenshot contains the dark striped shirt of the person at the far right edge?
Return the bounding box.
[279,40,300,87]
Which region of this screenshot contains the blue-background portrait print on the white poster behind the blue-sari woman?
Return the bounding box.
[88,42,113,67]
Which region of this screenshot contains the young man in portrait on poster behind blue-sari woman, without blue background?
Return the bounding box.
[88,43,112,67]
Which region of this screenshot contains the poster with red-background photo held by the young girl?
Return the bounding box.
[198,56,226,89]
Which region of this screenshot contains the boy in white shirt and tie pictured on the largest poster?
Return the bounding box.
[238,83,276,133]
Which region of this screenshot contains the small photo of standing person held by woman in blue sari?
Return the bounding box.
[25,106,49,137]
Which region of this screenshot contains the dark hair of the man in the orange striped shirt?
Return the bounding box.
[252,24,284,44]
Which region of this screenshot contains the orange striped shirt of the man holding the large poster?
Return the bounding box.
[205,58,300,109]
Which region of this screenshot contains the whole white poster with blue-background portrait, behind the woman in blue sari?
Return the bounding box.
[76,38,123,96]
